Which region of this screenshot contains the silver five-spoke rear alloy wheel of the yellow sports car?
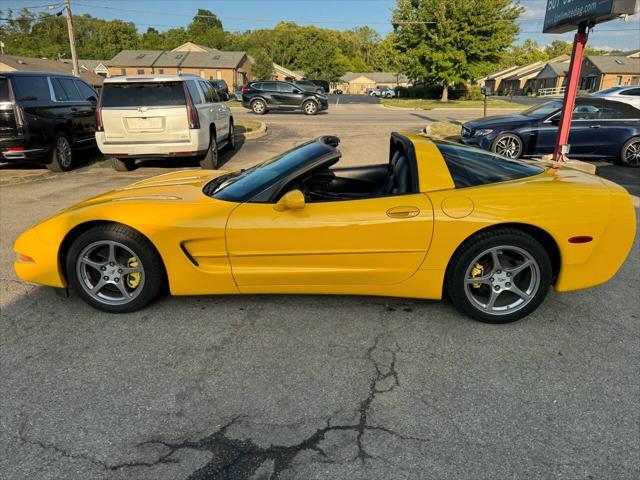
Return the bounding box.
[464,245,541,316]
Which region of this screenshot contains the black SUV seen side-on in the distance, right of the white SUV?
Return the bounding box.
[242,81,329,115]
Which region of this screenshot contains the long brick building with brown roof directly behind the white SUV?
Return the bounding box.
[108,42,253,89]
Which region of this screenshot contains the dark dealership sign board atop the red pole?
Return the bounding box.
[542,0,637,33]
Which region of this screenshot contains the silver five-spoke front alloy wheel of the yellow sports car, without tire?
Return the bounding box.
[76,240,145,305]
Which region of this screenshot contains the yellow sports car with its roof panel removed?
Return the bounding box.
[14,133,636,323]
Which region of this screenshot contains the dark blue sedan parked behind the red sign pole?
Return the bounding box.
[460,97,640,167]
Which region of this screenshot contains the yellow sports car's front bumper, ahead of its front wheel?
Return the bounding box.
[13,227,66,288]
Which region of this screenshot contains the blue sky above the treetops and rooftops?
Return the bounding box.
[0,0,640,50]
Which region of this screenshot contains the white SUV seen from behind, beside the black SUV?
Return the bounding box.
[96,75,235,171]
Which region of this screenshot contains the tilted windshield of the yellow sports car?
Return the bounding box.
[203,141,331,202]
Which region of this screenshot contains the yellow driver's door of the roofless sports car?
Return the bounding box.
[226,193,433,286]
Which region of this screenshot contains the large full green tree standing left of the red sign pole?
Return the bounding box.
[391,0,523,101]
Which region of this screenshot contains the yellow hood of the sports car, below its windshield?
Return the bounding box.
[65,169,228,211]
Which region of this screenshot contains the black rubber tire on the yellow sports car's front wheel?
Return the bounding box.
[65,224,166,313]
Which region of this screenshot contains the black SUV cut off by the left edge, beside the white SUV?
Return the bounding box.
[0,72,98,172]
